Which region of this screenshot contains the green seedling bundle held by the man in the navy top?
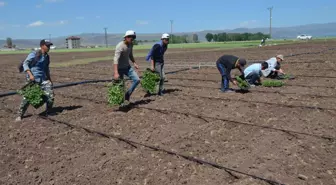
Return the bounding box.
[141,68,160,94]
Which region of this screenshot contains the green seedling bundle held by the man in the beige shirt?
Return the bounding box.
[107,79,125,106]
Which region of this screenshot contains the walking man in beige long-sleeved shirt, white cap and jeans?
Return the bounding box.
[113,30,140,101]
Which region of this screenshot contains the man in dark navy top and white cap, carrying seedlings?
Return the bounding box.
[146,33,169,96]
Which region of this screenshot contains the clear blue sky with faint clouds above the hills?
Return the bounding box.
[0,0,336,39]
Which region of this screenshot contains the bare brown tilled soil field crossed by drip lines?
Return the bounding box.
[0,41,336,185]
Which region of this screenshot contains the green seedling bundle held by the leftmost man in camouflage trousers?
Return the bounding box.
[18,82,46,109]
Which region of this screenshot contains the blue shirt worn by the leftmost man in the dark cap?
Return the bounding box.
[23,51,50,82]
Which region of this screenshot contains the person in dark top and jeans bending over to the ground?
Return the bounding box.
[216,55,246,92]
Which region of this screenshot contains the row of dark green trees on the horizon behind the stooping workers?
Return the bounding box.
[205,32,269,42]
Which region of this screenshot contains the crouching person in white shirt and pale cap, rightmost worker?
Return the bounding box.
[262,55,285,78]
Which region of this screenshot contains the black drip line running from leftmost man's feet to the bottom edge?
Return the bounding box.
[40,116,284,185]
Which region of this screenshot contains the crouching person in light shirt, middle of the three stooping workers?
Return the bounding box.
[244,62,268,87]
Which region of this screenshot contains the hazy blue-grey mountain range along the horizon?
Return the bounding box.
[0,22,336,48]
